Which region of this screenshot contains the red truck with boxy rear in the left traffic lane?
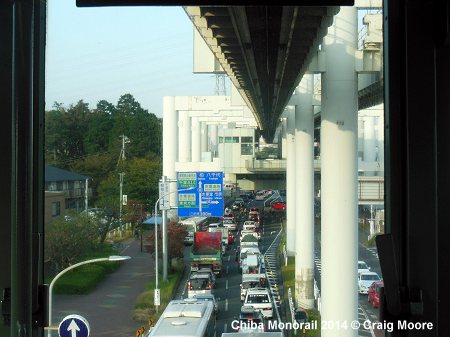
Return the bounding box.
[191,232,222,277]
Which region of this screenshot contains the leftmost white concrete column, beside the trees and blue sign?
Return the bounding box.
[163,96,178,206]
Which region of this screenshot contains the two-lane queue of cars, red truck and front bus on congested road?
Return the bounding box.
[154,189,273,337]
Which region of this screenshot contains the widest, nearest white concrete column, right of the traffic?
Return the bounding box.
[321,6,358,337]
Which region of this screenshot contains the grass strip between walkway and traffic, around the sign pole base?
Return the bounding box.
[132,261,184,324]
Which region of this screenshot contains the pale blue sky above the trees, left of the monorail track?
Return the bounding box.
[45,0,221,117]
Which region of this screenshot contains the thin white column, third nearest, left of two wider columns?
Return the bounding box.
[286,107,296,256]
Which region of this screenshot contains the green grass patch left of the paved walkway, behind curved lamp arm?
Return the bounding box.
[46,245,121,295]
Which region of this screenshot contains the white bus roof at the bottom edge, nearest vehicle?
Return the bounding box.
[145,298,216,337]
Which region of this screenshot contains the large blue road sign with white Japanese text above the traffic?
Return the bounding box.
[177,172,224,217]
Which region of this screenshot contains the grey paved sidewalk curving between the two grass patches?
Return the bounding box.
[52,238,155,337]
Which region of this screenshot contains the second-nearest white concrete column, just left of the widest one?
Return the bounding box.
[295,74,314,309]
